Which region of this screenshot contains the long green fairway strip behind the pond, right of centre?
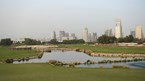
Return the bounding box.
[59,44,145,54]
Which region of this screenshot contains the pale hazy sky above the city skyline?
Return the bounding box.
[0,0,145,39]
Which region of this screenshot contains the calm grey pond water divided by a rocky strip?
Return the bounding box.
[14,50,145,68]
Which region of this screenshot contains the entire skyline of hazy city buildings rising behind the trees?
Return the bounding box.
[51,19,144,42]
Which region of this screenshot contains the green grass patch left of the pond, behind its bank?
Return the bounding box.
[0,46,39,60]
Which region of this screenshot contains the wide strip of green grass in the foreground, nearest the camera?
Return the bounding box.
[0,64,145,81]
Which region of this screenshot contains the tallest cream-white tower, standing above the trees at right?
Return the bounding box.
[115,19,122,38]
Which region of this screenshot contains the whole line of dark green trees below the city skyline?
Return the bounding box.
[0,35,144,46]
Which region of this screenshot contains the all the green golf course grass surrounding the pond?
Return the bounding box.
[0,44,145,81]
